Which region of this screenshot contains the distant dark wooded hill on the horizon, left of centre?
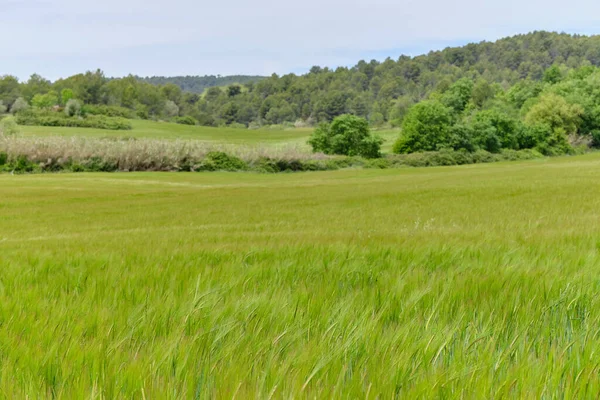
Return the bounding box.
[136,75,265,93]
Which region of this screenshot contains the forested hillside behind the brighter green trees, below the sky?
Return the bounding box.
[0,32,600,142]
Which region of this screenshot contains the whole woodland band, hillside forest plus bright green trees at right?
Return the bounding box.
[0,32,600,153]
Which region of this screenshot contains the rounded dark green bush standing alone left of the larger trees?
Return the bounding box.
[308,114,383,158]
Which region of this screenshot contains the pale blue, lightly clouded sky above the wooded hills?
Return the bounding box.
[0,0,600,80]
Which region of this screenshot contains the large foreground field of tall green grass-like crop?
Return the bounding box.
[0,154,600,399]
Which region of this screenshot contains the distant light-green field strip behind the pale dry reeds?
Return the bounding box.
[20,120,398,152]
